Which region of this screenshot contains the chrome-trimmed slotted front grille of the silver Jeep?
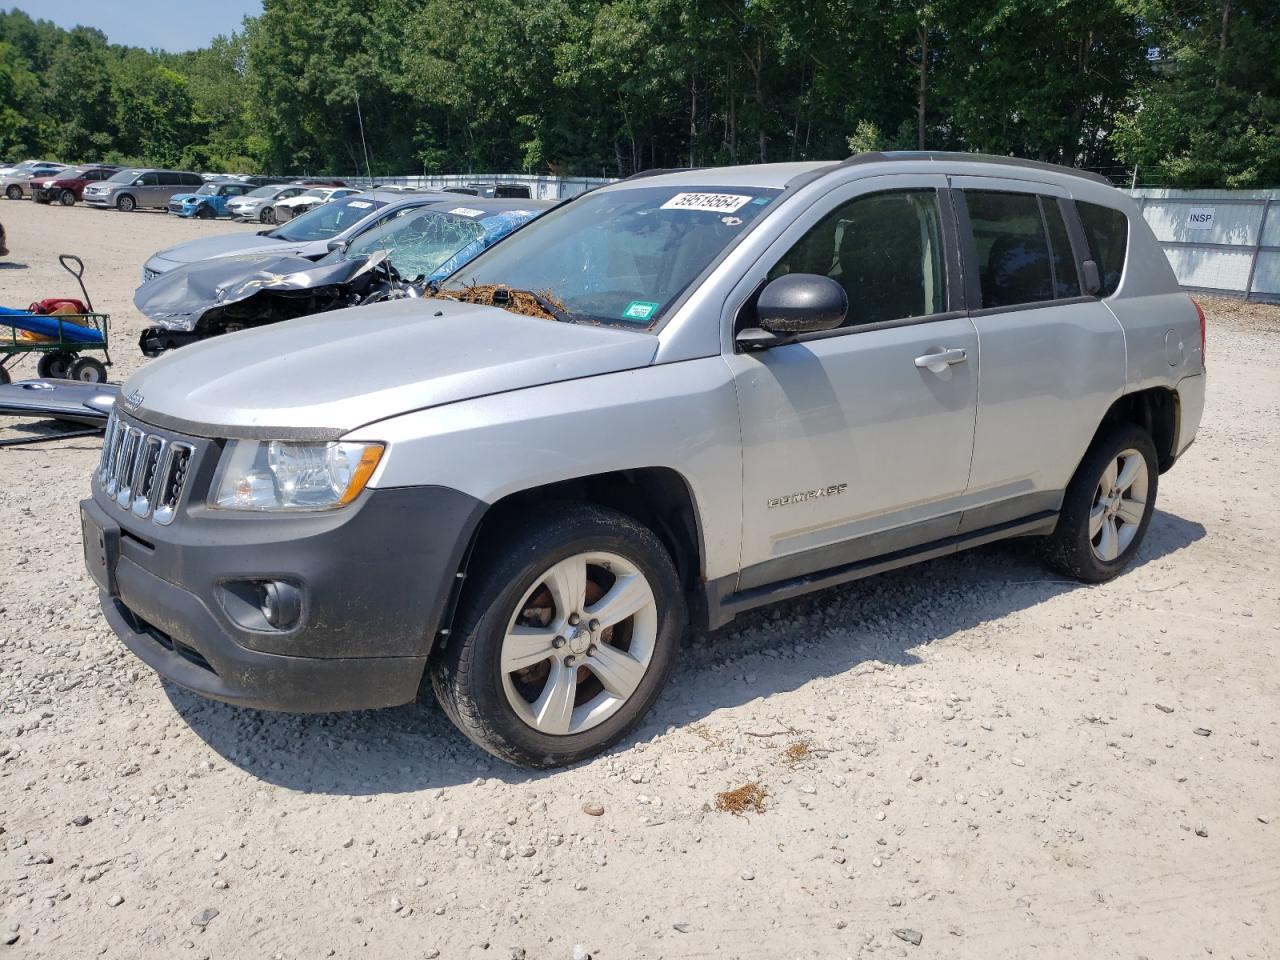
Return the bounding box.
[97,411,195,524]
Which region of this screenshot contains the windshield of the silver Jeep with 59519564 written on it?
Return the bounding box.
[443,186,780,329]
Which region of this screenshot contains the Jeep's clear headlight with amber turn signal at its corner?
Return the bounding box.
[209,440,383,511]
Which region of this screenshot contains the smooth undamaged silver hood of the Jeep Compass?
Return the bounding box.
[120,300,658,440]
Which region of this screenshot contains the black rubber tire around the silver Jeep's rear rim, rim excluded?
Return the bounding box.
[1041,424,1160,584]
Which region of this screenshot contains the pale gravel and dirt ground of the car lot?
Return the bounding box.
[0,202,1280,960]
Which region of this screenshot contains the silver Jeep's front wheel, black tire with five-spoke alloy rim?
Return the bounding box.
[431,503,686,767]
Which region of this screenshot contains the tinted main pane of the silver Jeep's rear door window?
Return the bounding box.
[964,189,1053,307]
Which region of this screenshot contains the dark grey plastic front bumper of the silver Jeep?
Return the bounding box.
[81,425,483,713]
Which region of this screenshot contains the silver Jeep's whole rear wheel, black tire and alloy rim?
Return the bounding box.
[1042,424,1160,584]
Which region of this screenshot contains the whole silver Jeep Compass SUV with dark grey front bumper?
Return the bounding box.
[82,154,1204,767]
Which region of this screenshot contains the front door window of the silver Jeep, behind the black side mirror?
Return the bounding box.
[769,189,947,326]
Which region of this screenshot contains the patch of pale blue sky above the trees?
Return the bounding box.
[0,0,262,52]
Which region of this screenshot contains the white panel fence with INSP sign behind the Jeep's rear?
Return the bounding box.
[1128,188,1280,302]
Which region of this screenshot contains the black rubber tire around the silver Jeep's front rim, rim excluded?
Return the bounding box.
[429,503,687,768]
